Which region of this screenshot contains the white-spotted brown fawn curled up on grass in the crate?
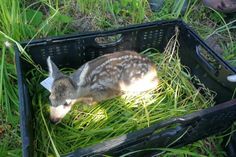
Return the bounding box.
[47,50,159,123]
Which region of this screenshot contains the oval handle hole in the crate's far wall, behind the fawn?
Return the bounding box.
[95,34,123,46]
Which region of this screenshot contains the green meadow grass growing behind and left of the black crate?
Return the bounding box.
[0,0,236,156]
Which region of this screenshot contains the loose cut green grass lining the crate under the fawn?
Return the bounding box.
[28,36,216,156]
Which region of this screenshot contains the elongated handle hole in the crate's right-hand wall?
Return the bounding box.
[197,46,222,76]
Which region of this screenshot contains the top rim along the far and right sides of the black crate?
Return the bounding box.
[14,19,236,74]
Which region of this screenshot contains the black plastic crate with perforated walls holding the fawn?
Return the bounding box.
[16,20,236,156]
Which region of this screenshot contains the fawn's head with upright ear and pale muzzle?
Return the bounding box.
[47,57,77,123]
